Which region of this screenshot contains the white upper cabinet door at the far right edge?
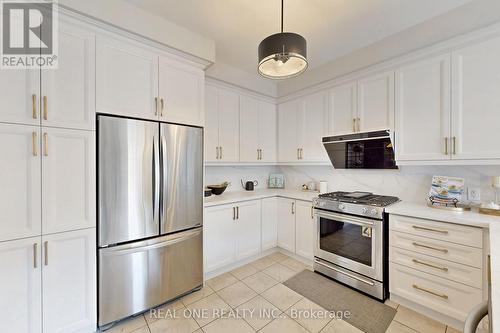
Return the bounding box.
[451,37,500,159]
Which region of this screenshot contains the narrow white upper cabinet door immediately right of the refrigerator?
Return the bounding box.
[204,85,219,162]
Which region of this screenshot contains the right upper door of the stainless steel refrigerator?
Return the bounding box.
[160,124,203,234]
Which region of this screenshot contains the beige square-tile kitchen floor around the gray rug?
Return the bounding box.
[99,252,459,333]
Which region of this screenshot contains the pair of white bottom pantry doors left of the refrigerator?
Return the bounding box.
[0,228,97,333]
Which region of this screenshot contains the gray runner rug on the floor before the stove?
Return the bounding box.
[283,270,396,333]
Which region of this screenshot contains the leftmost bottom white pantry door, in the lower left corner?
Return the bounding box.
[0,237,42,333]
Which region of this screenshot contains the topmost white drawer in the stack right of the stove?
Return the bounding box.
[390,215,483,248]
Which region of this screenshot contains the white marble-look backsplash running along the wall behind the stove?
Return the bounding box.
[205,166,500,202]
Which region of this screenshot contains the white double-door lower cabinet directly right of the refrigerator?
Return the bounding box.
[204,200,261,272]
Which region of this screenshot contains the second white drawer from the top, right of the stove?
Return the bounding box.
[389,230,483,268]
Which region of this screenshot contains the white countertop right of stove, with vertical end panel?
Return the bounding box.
[386,201,500,332]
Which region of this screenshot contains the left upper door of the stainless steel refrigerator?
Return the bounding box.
[98,116,160,247]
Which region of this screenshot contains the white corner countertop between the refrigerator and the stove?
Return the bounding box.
[204,189,319,207]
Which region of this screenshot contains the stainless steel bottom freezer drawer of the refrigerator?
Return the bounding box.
[99,228,203,326]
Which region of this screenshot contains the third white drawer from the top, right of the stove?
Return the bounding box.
[389,246,483,289]
